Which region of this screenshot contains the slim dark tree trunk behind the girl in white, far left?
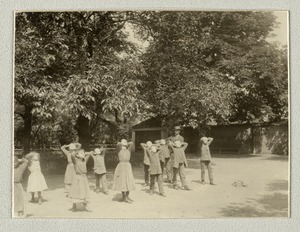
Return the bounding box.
[23,106,32,155]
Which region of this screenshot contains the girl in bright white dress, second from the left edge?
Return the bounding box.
[25,152,48,205]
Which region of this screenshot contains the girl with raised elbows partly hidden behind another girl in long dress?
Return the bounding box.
[60,143,81,194]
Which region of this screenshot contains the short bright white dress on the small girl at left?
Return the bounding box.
[27,160,48,192]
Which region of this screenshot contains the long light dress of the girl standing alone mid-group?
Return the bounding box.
[113,148,135,192]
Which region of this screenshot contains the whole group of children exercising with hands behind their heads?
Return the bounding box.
[14,130,214,216]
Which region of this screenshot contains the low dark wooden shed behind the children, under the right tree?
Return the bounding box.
[132,118,288,155]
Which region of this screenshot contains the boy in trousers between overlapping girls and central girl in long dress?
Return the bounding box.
[92,147,108,195]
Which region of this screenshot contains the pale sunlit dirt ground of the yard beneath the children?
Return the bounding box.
[18,155,289,218]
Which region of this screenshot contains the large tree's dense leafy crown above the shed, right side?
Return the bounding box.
[132,12,287,127]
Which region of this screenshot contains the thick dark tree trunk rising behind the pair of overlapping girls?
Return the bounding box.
[75,115,91,151]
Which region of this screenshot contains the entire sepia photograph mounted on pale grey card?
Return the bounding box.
[11,10,290,219]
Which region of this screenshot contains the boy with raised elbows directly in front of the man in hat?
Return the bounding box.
[170,141,190,190]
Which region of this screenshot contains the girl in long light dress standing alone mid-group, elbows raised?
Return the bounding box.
[113,139,135,203]
